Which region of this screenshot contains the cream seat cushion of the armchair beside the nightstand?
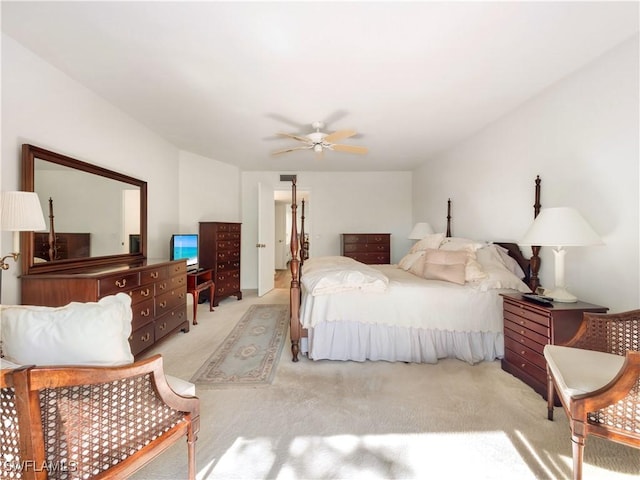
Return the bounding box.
[544,345,625,400]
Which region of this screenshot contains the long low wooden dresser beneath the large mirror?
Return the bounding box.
[21,260,189,356]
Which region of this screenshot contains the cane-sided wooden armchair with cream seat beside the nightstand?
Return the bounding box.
[544,310,640,480]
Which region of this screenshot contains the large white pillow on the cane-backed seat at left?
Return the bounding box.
[0,293,133,366]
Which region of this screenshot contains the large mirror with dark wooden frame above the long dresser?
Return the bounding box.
[20,144,147,275]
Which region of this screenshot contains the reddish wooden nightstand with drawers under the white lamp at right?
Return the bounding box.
[502,293,609,399]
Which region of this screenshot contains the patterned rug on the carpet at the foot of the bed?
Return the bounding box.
[191,305,289,388]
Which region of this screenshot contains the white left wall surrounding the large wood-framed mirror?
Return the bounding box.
[0,35,181,303]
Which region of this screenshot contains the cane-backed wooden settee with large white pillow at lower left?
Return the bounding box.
[0,294,200,480]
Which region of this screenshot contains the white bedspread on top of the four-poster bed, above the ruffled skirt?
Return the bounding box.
[300,265,504,334]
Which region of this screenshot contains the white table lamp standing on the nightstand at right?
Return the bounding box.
[519,207,604,303]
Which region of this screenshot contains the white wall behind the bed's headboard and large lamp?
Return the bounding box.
[413,37,640,311]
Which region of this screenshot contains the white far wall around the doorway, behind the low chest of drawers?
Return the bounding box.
[241,172,413,289]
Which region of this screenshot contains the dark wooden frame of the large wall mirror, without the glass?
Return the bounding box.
[20,144,147,275]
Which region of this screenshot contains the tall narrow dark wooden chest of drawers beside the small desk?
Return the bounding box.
[198,222,242,306]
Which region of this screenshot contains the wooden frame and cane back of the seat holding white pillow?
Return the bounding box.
[0,355,200,480]
